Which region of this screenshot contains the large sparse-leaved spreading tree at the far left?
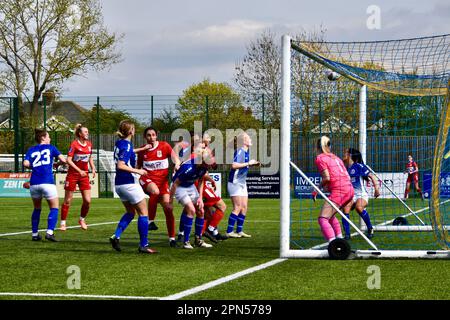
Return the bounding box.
[0,0,122,124]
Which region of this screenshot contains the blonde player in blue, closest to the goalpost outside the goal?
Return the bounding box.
[227,132,260,238]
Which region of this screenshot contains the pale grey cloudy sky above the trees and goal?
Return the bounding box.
[63,0,450,96]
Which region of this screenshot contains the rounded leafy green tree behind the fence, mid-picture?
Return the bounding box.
[177,80,259,130]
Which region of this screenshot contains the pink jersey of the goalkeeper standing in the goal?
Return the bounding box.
[316,153,353,193]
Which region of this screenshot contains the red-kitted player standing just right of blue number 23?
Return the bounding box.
[60,124,96,231]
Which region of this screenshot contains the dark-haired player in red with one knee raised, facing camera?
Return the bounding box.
[136,127,180,247]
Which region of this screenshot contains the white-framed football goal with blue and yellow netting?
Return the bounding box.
[280,35,450,258]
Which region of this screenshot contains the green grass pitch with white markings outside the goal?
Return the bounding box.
[0,198,450,300]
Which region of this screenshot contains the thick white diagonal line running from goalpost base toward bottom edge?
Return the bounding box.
[160,258,287,300]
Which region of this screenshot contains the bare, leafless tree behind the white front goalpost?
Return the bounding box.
[234,26,326,128]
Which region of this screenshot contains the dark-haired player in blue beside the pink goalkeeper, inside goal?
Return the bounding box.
[342,148,380,240]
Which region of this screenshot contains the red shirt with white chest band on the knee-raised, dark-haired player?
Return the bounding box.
[138,141,173,183]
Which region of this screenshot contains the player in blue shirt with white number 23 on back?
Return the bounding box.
[23,129,66,242]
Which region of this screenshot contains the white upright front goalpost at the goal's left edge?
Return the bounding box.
[280,35,291,257]
